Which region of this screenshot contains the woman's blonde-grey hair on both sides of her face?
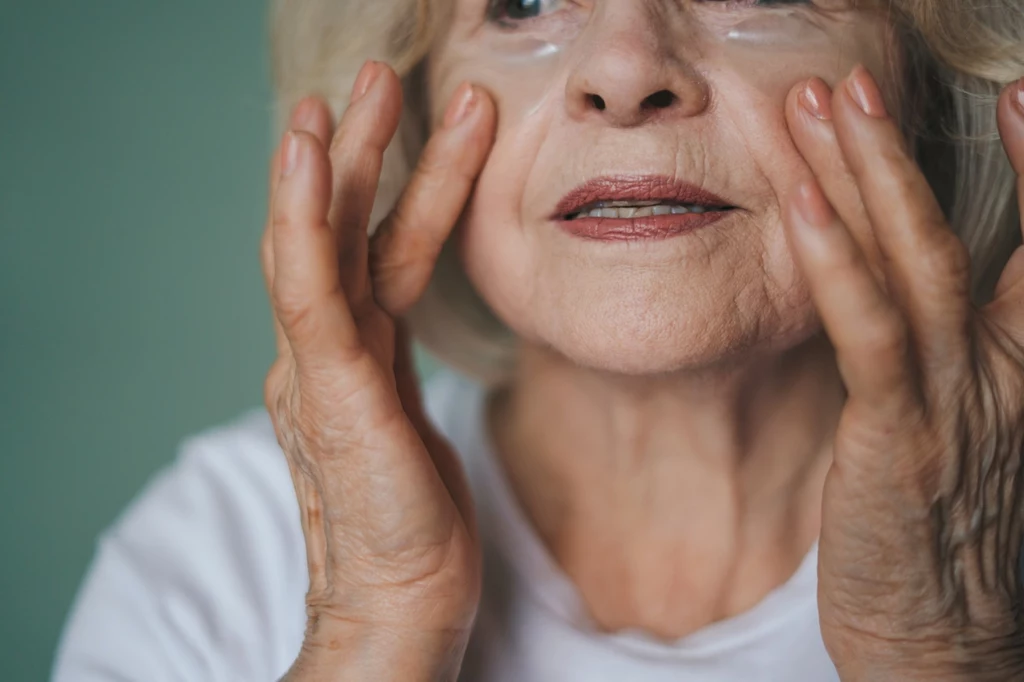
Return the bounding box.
[270,0,1024,381]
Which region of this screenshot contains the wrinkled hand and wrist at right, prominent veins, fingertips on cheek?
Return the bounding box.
[785,68,1024,682]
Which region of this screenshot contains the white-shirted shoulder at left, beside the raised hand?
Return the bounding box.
[53,410,308,682]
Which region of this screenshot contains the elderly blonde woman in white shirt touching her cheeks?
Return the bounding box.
[56,0,1024,682]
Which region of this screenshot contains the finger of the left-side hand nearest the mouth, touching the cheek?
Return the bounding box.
[370,83,497,315]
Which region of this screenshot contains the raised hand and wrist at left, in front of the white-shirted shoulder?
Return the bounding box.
[262,61,496,681]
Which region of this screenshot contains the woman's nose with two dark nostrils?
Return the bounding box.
[565,15,708,128]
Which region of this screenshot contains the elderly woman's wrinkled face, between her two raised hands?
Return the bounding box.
[428,0,891,373]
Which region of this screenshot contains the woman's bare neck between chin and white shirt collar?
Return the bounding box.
[489,339,844,640]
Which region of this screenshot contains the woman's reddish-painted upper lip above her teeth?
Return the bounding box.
[551,175,733,220]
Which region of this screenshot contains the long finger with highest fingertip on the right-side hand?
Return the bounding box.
[831,67,971,352]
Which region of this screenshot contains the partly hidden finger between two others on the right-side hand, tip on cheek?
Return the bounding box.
[785,78,885,282]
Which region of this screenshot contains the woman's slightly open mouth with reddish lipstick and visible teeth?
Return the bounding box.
[552,175,737,241]
